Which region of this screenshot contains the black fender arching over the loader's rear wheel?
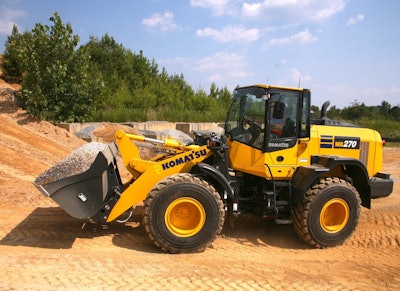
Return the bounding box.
[291,155,371,208]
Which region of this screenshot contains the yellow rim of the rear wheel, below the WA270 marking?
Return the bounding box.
[319,198,350,233]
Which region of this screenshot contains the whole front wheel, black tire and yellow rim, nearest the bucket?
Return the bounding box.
[143,173,225,253]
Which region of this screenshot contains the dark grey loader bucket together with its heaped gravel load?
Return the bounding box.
[34,143,123,219]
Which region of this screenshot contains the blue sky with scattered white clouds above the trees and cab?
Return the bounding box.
[0,0,400,108]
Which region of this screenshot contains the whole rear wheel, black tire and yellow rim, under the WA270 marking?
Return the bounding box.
[293,178,361,248]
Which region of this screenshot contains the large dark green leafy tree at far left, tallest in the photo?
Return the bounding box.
[22,13,101,122]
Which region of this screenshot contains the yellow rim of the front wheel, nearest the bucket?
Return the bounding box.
[165,197,206,237]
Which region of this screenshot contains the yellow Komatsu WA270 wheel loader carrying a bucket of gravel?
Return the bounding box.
[34,85,393,253]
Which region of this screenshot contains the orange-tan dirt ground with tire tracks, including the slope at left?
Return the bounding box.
[0,80,400,290]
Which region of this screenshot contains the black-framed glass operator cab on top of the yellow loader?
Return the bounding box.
[225,85,310,152]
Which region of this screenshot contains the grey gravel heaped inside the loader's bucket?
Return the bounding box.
[35,142,107,185]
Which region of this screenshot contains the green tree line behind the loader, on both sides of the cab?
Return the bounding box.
[3,13,400,139]
